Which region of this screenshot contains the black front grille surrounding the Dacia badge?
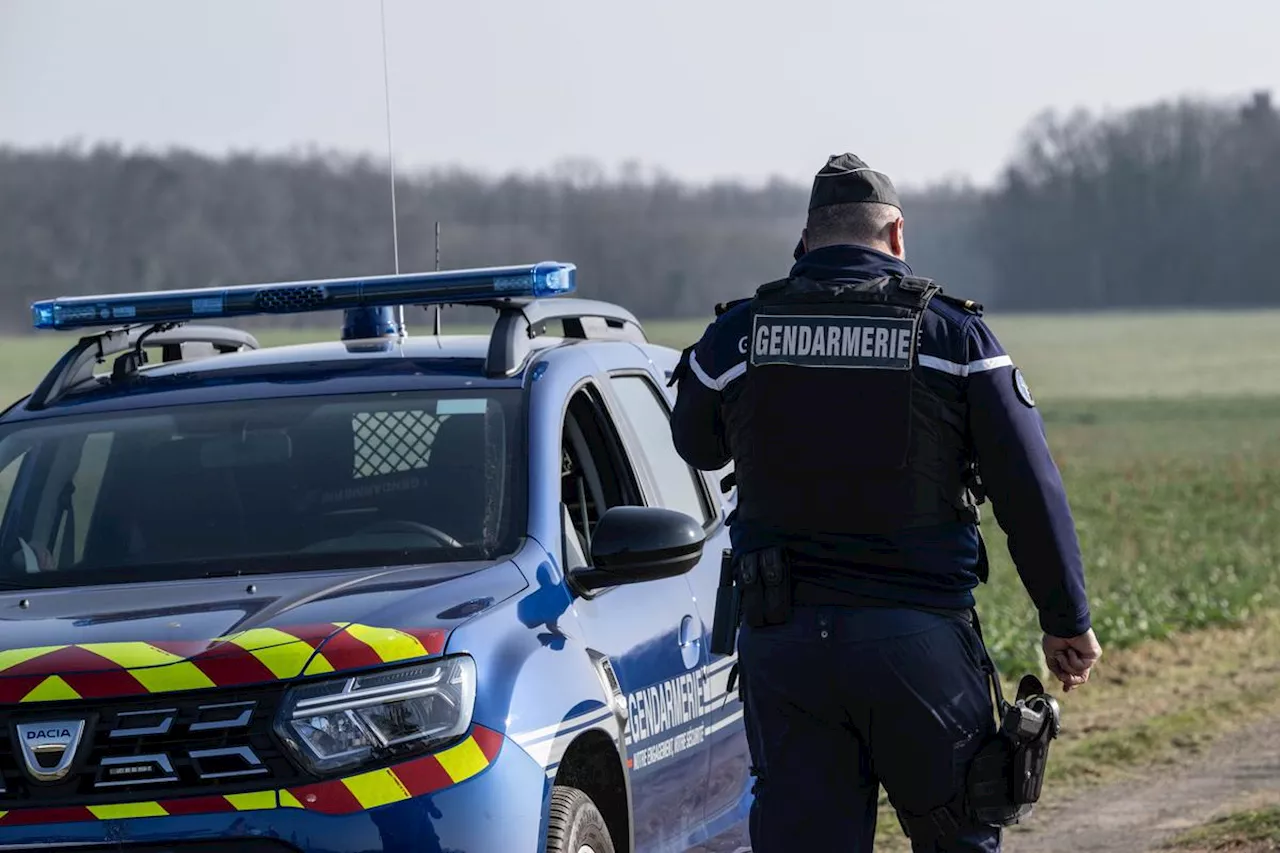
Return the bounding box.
[0,686,315,811]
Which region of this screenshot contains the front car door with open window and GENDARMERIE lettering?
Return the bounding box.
[561,382,707,850]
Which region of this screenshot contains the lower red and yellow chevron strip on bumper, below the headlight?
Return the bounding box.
[0,726,503,826]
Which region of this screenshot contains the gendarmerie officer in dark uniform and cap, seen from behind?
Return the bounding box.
[672,154,1101,853]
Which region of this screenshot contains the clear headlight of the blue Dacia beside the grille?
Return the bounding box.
[275,656,476,774]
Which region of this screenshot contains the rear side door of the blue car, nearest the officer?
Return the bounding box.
[599,370,750,840]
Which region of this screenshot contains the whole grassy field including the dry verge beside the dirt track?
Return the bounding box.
[0,311,1280,853]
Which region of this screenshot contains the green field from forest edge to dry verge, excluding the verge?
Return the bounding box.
[0,311,1280,671]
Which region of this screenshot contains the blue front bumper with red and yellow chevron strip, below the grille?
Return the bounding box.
[0,733,548,853]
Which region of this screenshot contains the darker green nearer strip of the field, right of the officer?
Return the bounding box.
[978,398,1280,671]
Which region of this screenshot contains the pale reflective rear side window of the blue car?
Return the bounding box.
[613,377,712,524]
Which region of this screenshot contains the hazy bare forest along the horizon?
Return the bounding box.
[0,93,1280,332]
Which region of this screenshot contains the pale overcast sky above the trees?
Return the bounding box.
[0,0,1280,184]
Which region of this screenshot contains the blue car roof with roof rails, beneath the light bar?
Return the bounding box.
[0,292,663,423]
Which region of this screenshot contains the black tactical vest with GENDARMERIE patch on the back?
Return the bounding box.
[726,277,978,534]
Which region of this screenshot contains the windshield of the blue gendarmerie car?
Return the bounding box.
[0,389,525,587]
